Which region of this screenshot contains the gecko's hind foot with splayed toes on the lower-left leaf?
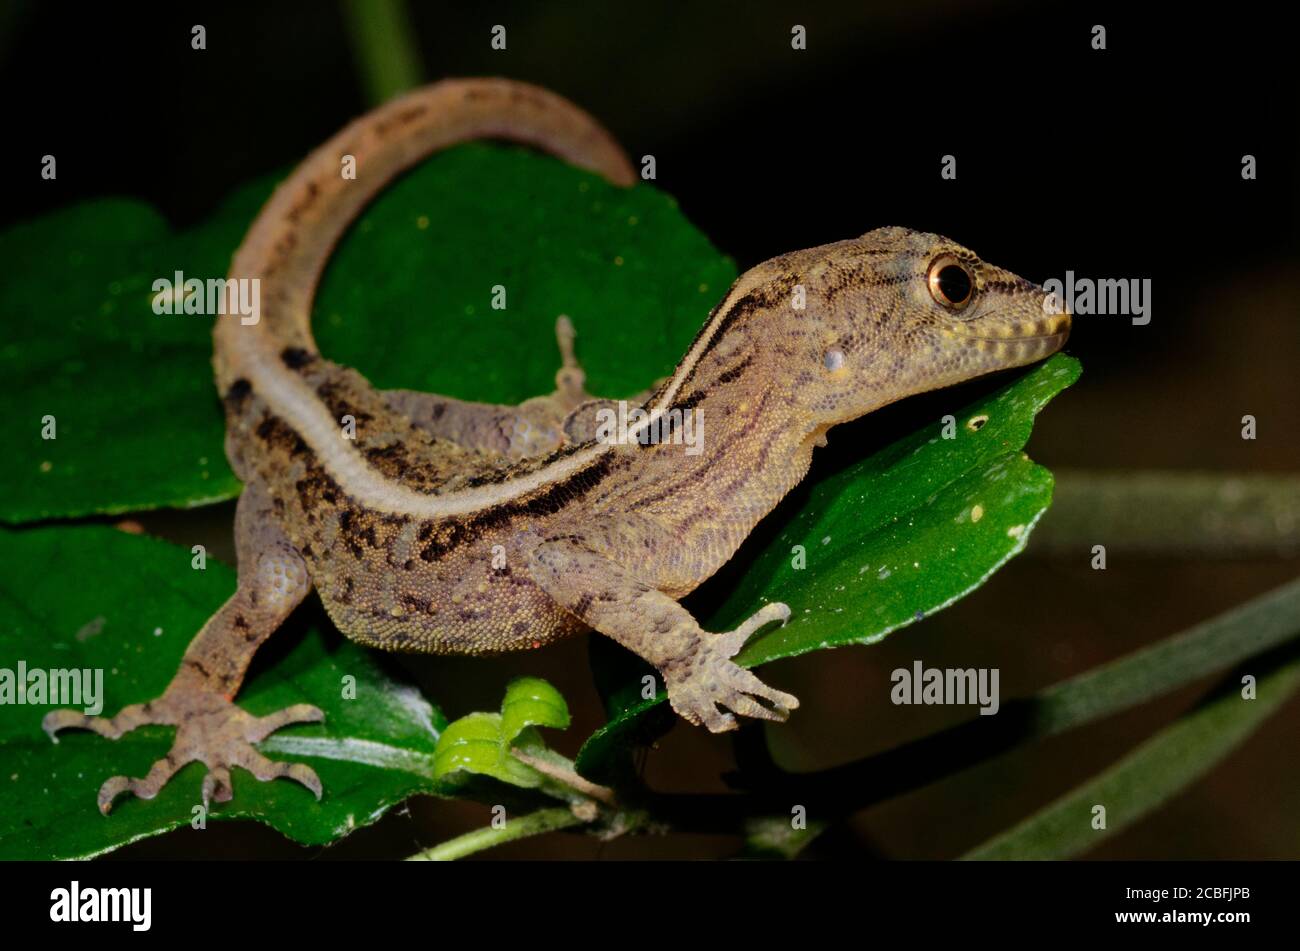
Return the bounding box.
[40,691,325,816]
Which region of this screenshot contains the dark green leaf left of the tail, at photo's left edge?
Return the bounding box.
[0,199,256,522]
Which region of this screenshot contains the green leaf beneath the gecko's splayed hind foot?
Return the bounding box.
[0,526,447,859]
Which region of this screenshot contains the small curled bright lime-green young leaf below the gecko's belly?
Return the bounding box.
[433,677,569,789]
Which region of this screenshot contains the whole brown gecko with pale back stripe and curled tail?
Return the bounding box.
[43,79,1071,815]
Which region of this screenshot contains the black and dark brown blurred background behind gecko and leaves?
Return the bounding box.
[0,0,1300,857]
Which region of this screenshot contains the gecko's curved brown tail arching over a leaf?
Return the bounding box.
[213,79,636,392]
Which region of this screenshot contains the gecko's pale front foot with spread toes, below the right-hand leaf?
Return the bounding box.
[662,603,800,733]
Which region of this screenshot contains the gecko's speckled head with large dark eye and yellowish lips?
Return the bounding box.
[794,227,1070,424]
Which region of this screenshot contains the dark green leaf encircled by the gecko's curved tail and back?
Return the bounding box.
[313,146,736,403]
